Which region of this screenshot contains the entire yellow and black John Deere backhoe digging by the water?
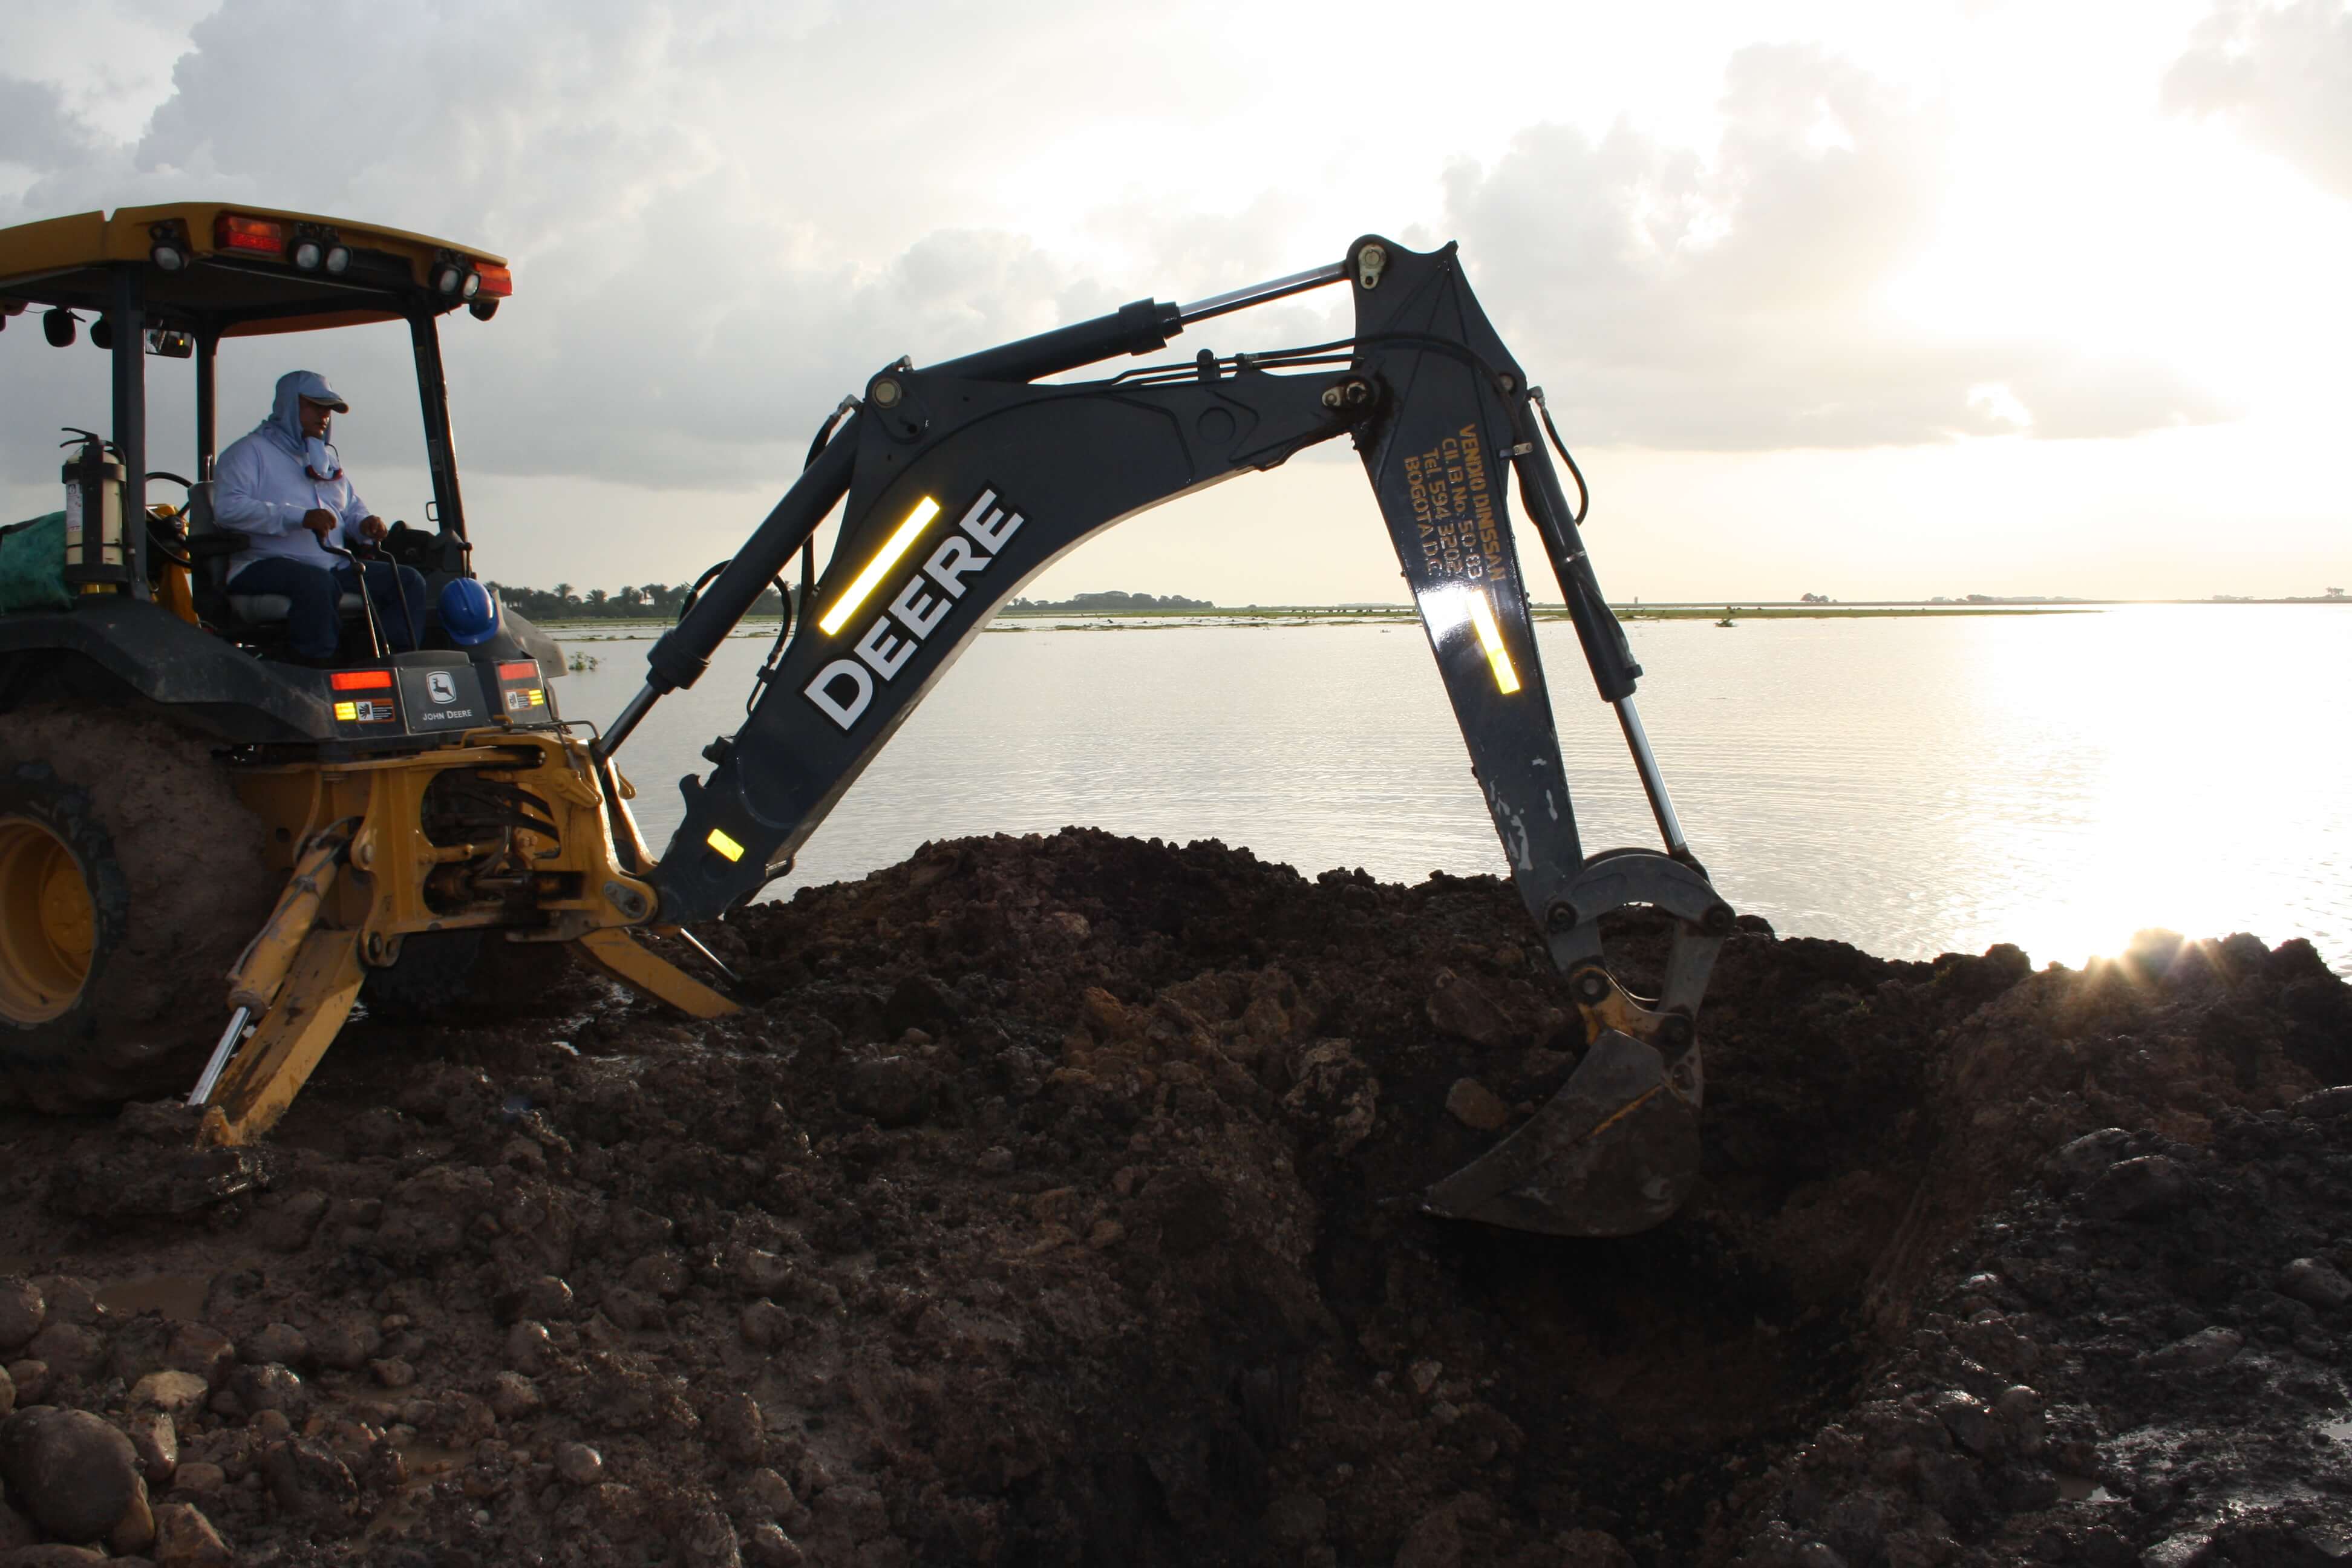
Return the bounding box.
[0,204,1731,1234]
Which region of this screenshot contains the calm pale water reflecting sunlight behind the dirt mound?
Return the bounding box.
[562,607,2352,973]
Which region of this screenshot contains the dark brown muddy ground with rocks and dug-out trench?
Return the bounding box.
[0,830,2352,1568]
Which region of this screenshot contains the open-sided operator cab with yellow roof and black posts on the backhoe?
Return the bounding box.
[0,202,562,738]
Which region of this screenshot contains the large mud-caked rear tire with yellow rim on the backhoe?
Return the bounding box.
[0,708,284,1112]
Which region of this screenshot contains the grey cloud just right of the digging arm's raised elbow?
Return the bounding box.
[1444,47,2225,449]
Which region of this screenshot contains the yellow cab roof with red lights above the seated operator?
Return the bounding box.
[0,202,513,336]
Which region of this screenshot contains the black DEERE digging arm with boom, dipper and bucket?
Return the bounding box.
[626,237,1731,1234]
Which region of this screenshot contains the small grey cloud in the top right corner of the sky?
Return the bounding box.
[2164,0,2352,197]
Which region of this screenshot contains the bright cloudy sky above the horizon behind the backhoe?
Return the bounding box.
[0,0,2352,604]
